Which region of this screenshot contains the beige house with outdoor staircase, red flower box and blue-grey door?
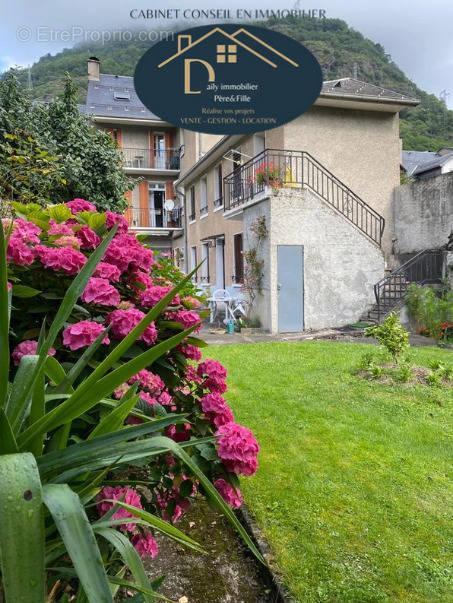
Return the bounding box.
[175,78,418,332]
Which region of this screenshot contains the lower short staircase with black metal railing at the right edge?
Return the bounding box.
[361,249,445,324]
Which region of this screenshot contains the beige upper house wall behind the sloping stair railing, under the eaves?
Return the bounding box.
[283,106,401,260]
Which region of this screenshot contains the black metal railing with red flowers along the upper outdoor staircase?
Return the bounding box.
[223,149,385,245]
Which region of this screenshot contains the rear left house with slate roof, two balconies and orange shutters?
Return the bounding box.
[80,57,184,251]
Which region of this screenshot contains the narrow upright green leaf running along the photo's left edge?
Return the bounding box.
[0,220,11,408]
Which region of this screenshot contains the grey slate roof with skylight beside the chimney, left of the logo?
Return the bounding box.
[79,73,160,120]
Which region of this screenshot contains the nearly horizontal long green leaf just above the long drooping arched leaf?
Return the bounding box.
[37,415,189,475]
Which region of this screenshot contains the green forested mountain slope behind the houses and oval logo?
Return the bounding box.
[8,17,453,150]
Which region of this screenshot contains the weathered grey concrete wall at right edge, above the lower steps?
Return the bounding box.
[394,173,453,254]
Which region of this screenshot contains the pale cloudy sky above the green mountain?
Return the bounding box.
[0,0,453,109]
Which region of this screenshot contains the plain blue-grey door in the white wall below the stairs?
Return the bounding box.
[277,245,304,333]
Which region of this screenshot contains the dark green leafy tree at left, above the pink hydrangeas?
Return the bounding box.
[0,73,132,212]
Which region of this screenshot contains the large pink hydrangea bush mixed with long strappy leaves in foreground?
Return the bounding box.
[0,199,259,602]
